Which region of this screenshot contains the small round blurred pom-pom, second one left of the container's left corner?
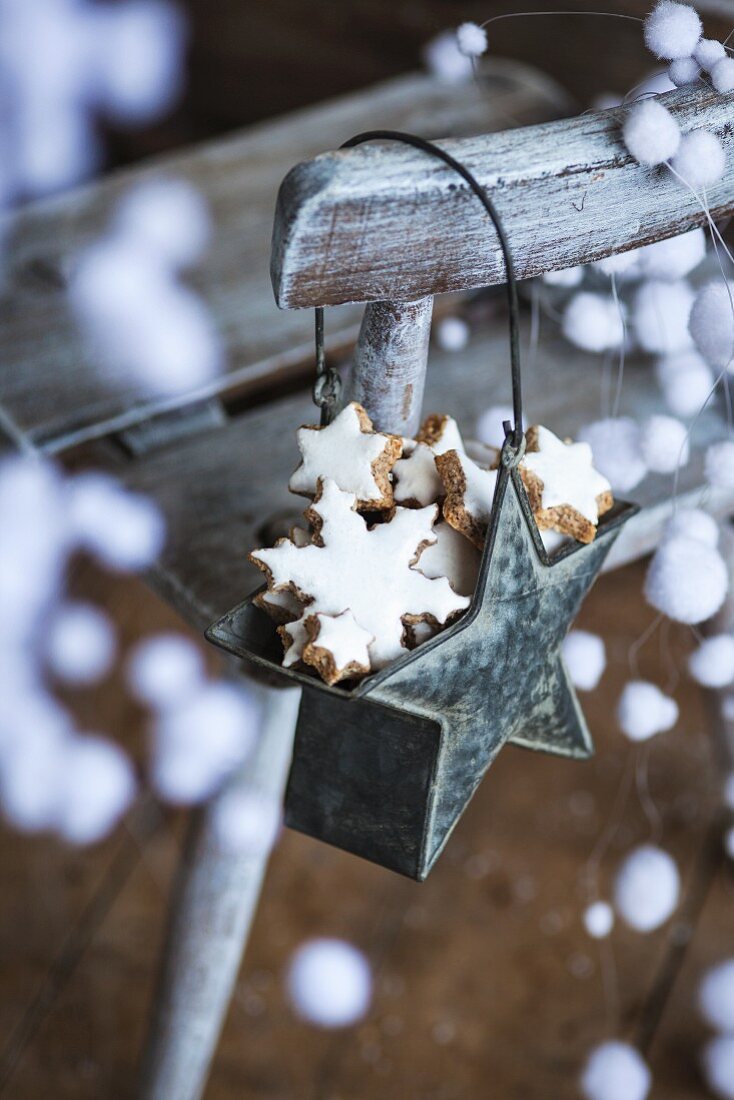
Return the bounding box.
[46,604,117,684]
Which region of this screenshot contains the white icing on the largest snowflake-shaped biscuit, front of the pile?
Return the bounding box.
[251,479,469,669]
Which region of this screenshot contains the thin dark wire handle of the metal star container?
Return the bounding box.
[314,130,524,451]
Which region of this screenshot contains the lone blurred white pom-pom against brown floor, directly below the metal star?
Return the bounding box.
[287,939,372,1027]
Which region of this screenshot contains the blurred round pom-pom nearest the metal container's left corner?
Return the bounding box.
[128,634,205,711]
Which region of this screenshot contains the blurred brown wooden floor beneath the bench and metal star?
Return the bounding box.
[0,558,734,1100]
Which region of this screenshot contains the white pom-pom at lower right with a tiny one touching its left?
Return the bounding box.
[614,844,680,932]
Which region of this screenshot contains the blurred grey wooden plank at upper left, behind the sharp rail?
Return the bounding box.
[0,61,568,450]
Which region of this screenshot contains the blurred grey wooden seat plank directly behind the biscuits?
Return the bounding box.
[123,321,734,628]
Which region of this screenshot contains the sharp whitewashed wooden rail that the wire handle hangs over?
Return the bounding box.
[273,88,734,309]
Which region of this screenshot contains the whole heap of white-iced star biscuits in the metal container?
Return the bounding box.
[250,402,613,684]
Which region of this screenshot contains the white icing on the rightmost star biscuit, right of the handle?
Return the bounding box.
[522,426,612,524]
